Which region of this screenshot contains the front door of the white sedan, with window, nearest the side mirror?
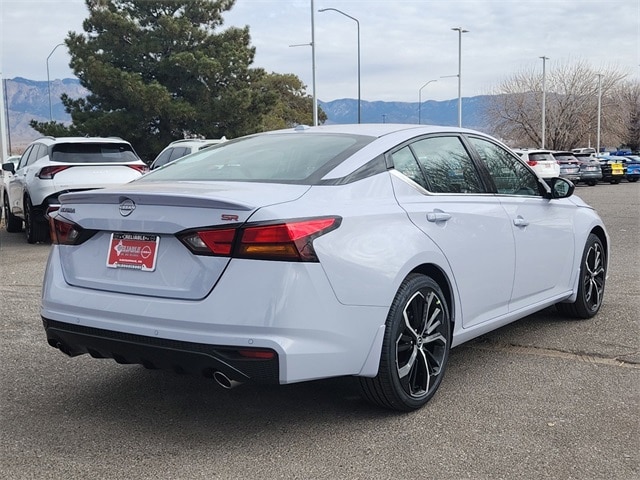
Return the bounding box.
[469,136,575,311]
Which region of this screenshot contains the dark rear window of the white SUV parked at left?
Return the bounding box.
[51,143,138,163]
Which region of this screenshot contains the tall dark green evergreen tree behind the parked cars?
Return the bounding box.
[32,0,279,160]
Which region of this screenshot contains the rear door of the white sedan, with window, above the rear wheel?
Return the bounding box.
[390,135,515,328]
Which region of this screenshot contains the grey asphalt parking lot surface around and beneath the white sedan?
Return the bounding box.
[0,182,640,480]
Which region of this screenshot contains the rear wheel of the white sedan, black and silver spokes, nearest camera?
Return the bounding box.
[360,274,452,412]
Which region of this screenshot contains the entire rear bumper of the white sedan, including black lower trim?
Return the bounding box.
[40,251,388,384]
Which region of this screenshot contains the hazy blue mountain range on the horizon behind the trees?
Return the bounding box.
[4,77,489,153]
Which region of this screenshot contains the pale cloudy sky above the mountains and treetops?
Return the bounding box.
[0,0,640,101]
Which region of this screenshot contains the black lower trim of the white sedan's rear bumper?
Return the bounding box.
[42,317,279,384]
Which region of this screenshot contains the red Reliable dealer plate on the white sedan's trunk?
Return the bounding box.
[107,233,160,272]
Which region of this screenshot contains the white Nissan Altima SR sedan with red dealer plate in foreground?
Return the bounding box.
[41,124,609,411]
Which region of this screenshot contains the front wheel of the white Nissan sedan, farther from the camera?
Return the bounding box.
[556,233,607,319]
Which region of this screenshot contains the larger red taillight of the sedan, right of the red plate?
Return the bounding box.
[178,217,342,262]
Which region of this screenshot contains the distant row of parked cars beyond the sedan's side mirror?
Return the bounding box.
[515,149,640,186]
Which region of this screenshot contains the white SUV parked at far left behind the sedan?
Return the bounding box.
[2,137,148,243]
